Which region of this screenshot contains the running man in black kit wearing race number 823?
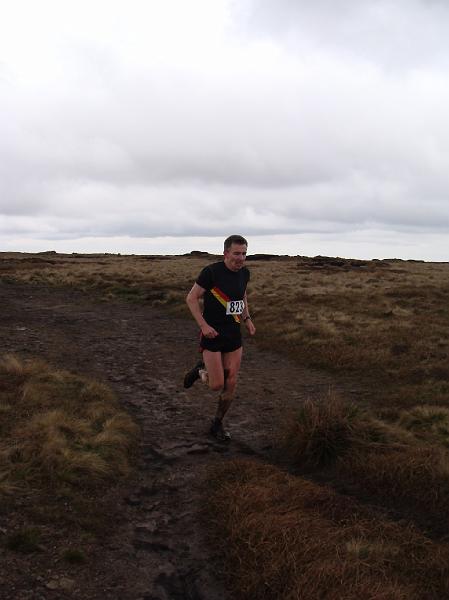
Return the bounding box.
[184,235,256,441]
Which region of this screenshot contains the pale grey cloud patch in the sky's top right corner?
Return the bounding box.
[242,0,449,69]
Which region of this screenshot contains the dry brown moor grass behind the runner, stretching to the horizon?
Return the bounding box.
[0,248,449,408]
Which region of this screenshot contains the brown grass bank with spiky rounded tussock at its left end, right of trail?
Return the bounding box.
[280,395,449,535]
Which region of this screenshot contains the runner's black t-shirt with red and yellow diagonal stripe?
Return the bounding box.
[196,261,249,331]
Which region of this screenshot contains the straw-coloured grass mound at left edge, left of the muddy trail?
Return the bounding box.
[0,355,139,580]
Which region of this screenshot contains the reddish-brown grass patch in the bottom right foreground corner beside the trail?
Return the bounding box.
[206,461,449,600]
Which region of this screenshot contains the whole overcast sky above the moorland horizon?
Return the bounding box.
[0,0,449,261]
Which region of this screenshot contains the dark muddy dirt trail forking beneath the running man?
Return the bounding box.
[0,284,368,600]
